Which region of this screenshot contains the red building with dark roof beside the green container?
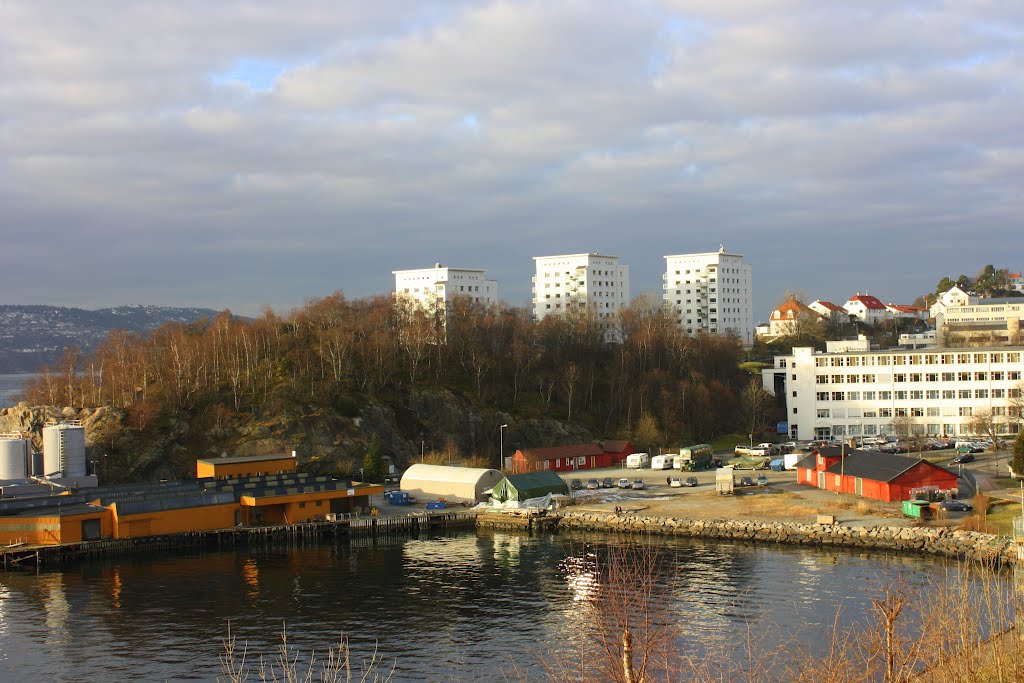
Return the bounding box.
[797,446,957,503]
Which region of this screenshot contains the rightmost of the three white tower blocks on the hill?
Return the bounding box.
[663,247,754,345]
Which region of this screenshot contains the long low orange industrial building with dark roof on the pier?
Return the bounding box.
[0,457,384,545]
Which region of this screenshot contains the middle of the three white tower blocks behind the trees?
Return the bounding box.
[532,253,630,324]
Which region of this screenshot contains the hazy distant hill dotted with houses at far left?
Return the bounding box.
[0,305,219,373]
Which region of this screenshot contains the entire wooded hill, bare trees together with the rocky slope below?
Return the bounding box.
[16,293,772,477]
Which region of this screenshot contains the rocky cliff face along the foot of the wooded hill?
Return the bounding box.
[0,388,596,481]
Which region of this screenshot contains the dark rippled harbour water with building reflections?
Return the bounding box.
[0,532,1007,681]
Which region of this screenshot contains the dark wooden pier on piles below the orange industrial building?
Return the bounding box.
[0,511,477,571]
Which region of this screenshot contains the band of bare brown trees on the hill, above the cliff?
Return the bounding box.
[26,293,771,442]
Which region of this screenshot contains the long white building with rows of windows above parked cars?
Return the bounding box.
[762,340,1024,439]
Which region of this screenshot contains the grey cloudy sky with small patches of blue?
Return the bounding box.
[0,0,1024,319]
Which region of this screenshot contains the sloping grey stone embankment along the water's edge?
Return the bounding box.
[559,512,1017,564]
